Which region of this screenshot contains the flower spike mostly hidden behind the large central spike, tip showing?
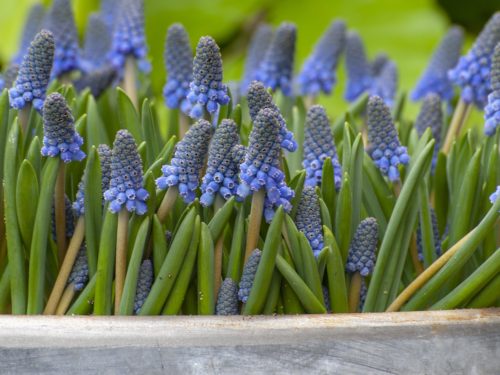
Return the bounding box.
[247,81,297,152]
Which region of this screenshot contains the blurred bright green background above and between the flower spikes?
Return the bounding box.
[0,0,500,115]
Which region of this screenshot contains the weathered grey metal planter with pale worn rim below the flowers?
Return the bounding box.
[0,309,500,375]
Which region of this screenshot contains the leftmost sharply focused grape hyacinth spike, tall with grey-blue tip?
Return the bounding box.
[9,30,54,112]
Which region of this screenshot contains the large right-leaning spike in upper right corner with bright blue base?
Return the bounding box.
[448,12,500,109]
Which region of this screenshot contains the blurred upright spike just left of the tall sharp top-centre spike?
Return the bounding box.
[163,23,193,113]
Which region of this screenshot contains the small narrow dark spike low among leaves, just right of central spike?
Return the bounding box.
[295,186,323,257]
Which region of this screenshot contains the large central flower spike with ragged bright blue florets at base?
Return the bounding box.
[237,108,294,222]
